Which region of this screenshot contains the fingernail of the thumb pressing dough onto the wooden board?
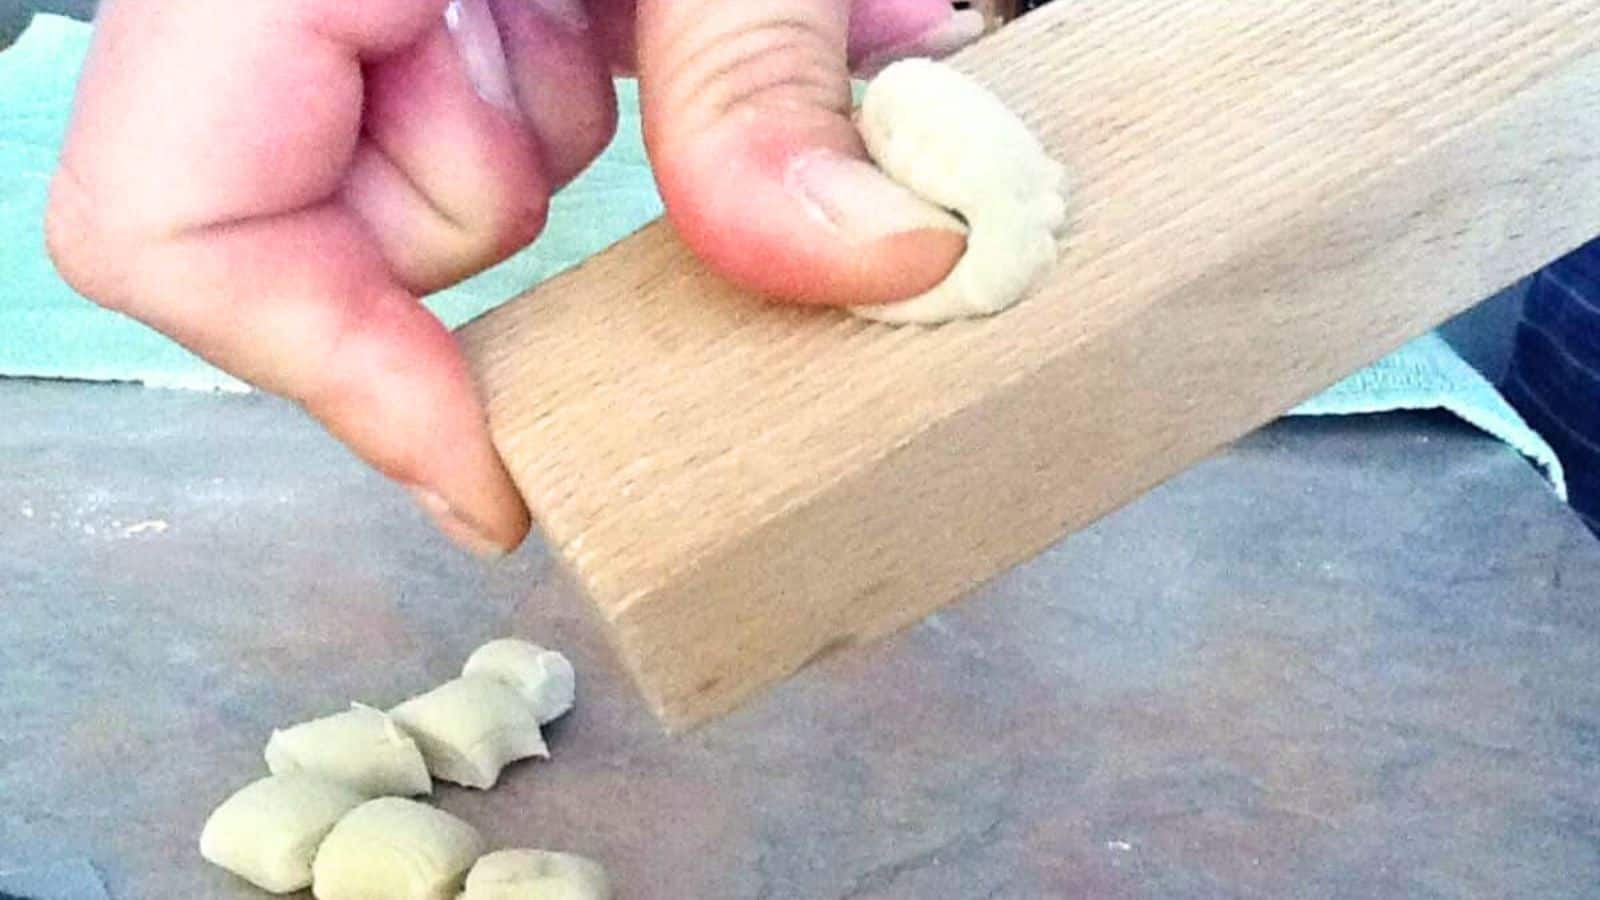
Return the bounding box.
[786,151,966,243]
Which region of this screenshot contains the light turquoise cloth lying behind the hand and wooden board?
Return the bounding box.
[0,16,1565,496]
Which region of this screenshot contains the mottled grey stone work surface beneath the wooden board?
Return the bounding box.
[0,381,1600,900]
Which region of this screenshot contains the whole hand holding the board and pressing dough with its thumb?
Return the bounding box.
[46,0,976,554]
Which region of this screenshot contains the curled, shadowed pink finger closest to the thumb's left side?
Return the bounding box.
[490,0,616,187]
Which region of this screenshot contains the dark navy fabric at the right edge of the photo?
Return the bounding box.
[1501,240,1600,535]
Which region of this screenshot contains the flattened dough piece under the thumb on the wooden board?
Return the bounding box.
[851,59,1067,323]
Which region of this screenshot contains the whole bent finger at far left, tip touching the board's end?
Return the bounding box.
[48,0,526,546]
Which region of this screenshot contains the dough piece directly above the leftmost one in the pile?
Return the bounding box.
[267,703,434,798]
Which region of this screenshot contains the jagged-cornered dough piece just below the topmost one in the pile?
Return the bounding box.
[389,676,550,790]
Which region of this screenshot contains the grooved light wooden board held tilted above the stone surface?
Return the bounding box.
[462,0,1600,727]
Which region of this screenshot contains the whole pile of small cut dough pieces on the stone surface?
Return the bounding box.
[200,639,611,900]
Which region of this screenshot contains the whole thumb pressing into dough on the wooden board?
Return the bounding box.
[638,0,965,304]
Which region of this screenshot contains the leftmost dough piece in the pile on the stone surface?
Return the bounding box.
[200,775,366,894]
